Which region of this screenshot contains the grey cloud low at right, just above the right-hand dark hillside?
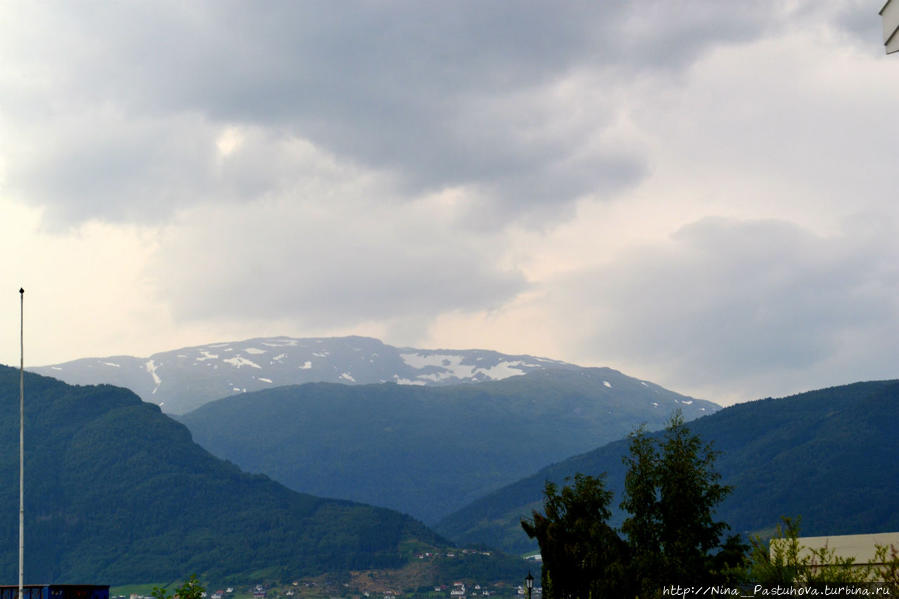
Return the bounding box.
[562,220,899,399]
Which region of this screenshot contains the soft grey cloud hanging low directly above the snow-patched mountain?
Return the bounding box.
[154,206,526,329]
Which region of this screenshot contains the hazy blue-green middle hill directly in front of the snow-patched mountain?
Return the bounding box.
[179,368,719,522]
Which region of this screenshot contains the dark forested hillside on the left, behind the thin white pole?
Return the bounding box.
[0,366,445,584]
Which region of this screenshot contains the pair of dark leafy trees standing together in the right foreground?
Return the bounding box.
[521,414,746,599]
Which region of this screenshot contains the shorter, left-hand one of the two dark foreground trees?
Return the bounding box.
[521,474,627,599]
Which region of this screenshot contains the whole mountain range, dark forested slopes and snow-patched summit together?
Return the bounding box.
[19,337,899,582]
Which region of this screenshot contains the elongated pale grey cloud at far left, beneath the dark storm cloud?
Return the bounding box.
[5,111,366,228]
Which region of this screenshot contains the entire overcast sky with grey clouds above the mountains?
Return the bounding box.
[0,0,899,404]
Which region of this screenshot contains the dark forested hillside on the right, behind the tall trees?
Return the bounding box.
[436,381,899,551]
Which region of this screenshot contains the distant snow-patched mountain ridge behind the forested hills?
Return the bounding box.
[29,337,579,414]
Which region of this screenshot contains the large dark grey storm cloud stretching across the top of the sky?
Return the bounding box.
[8,1,772,226]
